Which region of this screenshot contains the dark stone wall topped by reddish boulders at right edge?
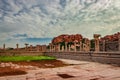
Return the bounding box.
[100,32,120,51]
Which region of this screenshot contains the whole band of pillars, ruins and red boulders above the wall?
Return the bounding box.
[1,32,120,52]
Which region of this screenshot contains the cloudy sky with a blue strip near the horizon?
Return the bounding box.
[0,0,120,47]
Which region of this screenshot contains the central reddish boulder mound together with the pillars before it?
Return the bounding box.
[49,34,90,51]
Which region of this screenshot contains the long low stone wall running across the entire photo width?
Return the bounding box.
[0,51,120,65]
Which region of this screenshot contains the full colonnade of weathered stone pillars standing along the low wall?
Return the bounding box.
[3,34,120,52]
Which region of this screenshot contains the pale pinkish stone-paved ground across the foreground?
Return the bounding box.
[0,59,120,80]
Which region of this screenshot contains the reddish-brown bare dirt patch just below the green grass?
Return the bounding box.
[0,60,67,76]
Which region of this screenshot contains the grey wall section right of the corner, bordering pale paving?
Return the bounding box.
[44,52,120,65]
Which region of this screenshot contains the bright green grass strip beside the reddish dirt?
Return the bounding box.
[0,56,55,62]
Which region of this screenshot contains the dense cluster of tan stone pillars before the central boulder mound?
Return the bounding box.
[49,41,90,52]
